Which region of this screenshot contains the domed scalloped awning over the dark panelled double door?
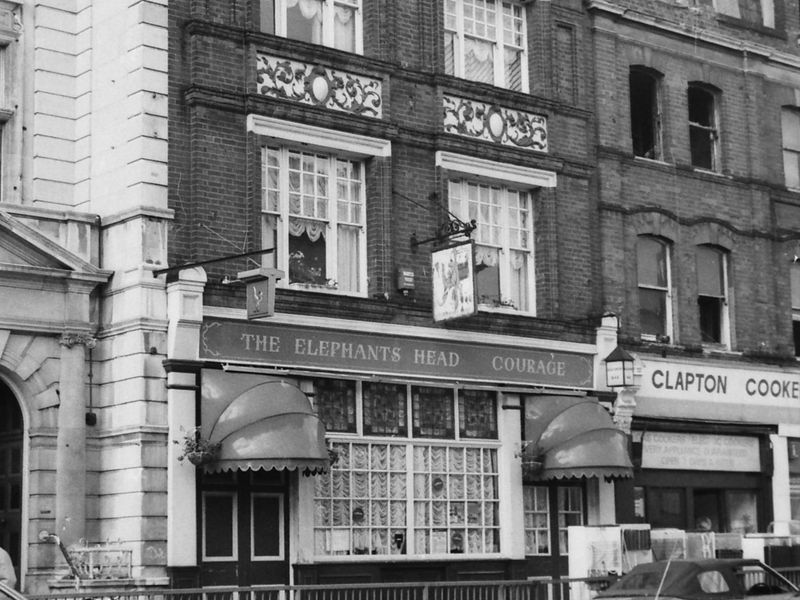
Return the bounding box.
[201,370,329,473]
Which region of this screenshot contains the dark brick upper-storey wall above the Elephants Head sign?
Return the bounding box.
[170,0,601,341]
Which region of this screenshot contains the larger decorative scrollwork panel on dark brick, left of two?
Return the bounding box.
[256,54,383,119]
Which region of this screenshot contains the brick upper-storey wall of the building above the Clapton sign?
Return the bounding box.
[594,2,800,357]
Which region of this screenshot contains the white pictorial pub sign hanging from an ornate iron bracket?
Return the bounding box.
[431,240,478,322]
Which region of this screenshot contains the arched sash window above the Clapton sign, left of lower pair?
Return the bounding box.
[636,236,672,342]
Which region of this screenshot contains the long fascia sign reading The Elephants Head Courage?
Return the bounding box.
[199,318,594,389]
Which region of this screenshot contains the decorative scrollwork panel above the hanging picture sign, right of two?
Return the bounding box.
[442,95,547,152]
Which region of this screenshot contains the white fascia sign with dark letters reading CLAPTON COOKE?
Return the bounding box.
[640,359,800,406]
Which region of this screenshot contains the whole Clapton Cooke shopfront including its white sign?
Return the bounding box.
[617,354,800,536]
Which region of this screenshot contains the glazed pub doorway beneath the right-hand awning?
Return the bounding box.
[522,482,585,578]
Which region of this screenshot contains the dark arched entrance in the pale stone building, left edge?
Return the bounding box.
[0,381,23,580]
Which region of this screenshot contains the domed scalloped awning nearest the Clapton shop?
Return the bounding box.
[522,396,633,481]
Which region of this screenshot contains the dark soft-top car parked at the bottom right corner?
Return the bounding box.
[596,558,800,600]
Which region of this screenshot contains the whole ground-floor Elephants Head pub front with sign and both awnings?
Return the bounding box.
[165,269,632,586]
